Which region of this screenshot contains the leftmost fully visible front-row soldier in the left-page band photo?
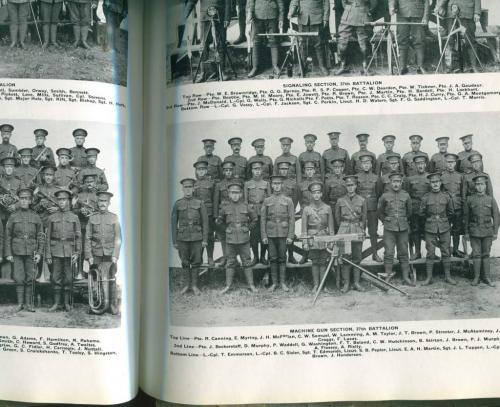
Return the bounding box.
[5,188,43,312]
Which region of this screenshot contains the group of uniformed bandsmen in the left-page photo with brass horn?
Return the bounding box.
[0,124,121,314]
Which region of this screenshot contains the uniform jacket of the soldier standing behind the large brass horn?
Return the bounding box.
[84,211,122,259]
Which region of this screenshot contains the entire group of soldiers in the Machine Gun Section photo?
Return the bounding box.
[172,132,498,293]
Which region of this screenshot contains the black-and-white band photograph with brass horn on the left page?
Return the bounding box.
[0,119,125,329]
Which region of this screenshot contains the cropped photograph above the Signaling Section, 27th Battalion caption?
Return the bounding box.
[167,0,500,85]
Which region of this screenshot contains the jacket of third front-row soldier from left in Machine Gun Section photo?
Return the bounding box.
[260,194,295,240]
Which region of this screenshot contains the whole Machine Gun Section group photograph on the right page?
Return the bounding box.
[169,113,500,326]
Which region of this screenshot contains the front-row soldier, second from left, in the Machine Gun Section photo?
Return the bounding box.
[216,182,257,294]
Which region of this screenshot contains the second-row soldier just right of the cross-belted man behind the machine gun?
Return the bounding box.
[356,154,382,263]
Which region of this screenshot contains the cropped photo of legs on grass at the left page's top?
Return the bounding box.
[0,0,128,86]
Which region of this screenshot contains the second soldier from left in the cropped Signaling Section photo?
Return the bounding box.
[247,0,284,78]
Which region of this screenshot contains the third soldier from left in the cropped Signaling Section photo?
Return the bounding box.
[288,0,330,76]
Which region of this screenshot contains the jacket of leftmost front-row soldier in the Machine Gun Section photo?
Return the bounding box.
[172,198,208,244]
